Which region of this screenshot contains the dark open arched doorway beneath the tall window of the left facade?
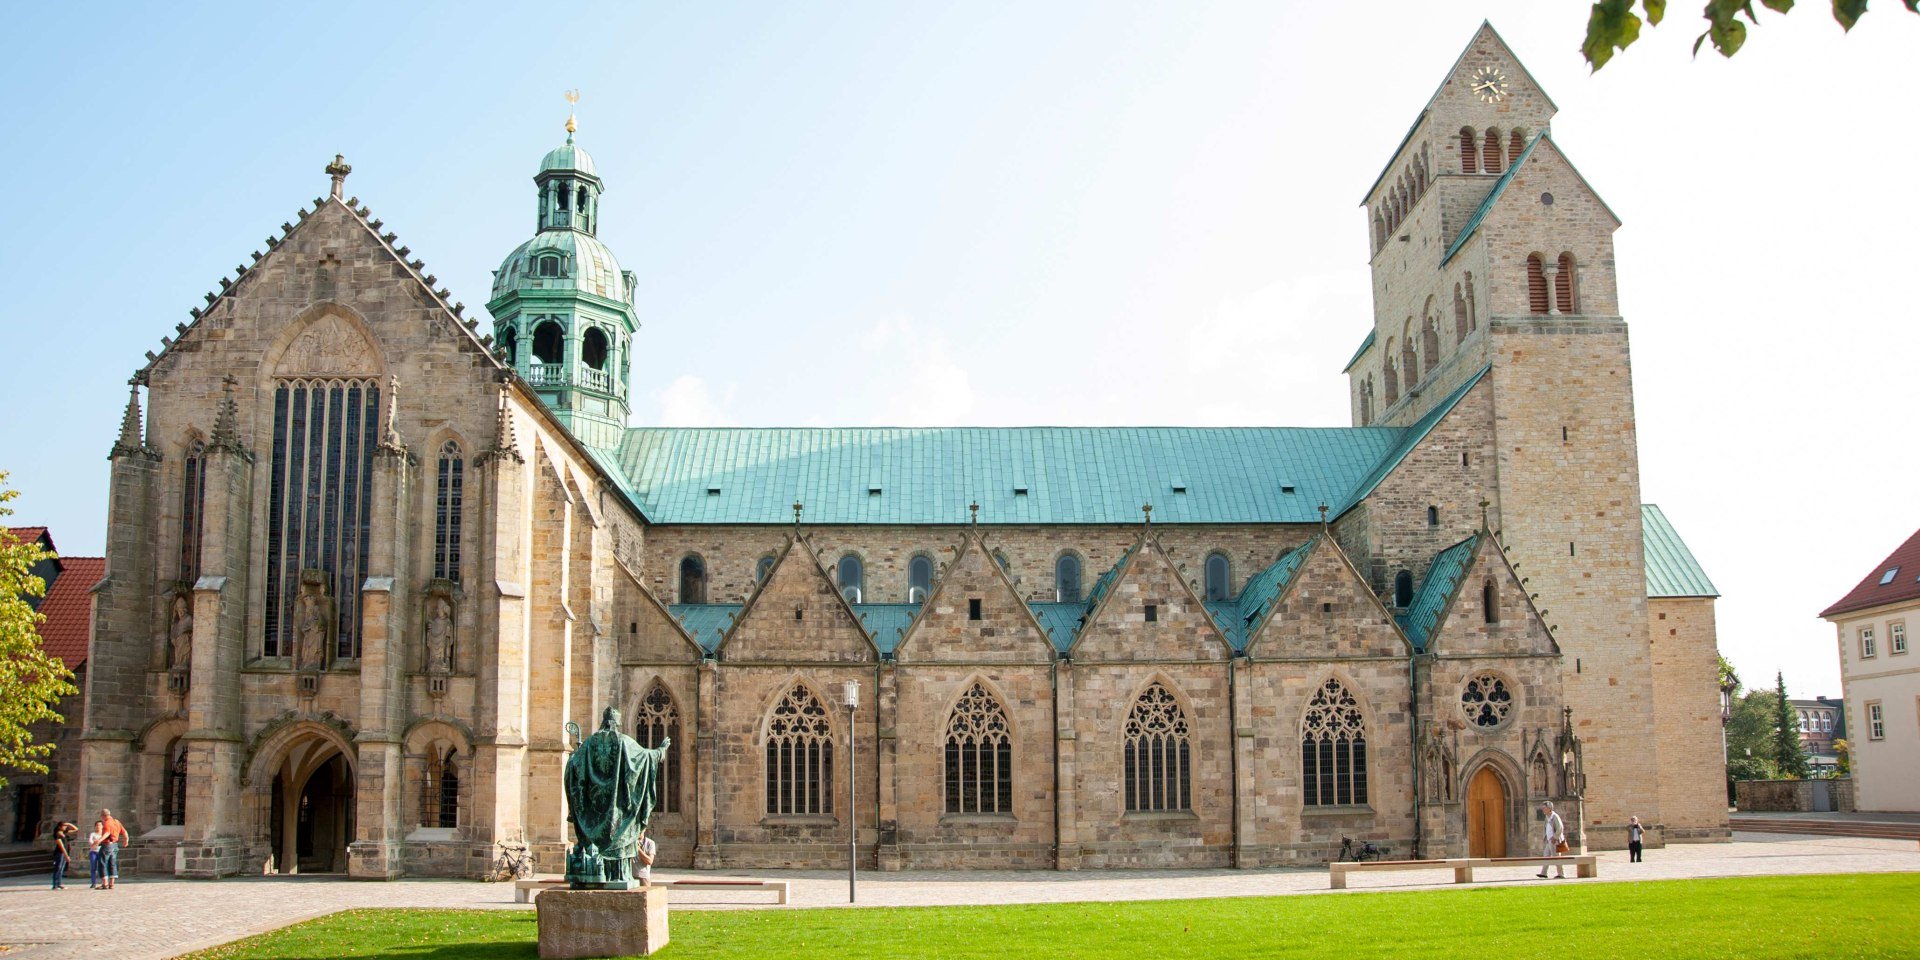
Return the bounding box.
[269,737,353,874]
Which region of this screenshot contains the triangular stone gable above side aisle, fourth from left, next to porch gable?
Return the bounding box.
[1242,532,1409,660]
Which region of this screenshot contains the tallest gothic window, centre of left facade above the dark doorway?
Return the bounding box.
[261,378,380,659]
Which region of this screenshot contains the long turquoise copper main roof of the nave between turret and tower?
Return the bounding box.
[612,426,1407,524]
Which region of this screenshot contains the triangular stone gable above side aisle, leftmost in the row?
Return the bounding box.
[718,536,879,662]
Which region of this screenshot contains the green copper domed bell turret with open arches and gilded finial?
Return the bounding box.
[486,103,639,449]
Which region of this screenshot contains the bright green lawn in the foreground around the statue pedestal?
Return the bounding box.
[192,874,1920,960]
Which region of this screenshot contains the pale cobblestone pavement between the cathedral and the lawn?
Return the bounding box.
[0,833,1920,960]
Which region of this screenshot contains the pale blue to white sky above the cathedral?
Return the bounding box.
[0,0,1920,697]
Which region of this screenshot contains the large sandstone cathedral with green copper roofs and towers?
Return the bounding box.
[74,25,1728,877]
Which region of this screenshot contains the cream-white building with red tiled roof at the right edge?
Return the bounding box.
[1820,532,1920,812]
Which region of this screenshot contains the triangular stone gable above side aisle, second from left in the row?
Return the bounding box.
[895,530,1054,662]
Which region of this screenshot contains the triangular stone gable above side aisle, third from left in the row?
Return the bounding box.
[1069,534,1233,660]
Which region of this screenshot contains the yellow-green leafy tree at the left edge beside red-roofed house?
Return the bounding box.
[0,470,79,789]
